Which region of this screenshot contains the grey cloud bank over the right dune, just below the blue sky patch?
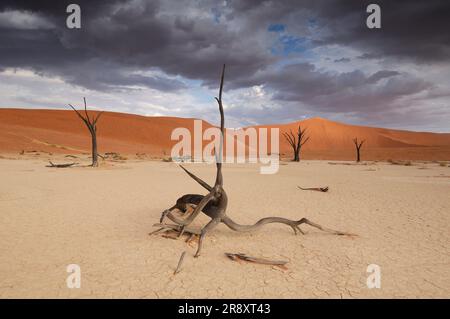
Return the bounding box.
[230,63,433,114]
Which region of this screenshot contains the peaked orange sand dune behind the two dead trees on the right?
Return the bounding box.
[260,117,450,160]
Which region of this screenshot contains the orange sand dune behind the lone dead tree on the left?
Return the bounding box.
[0,109,211,156]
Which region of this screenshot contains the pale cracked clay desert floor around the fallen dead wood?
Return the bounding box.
[0,158,450,298]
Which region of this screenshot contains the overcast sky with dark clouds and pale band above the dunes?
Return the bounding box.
[0,0,450,132]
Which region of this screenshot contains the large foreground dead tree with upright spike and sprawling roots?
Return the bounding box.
[158,65,352,257]
